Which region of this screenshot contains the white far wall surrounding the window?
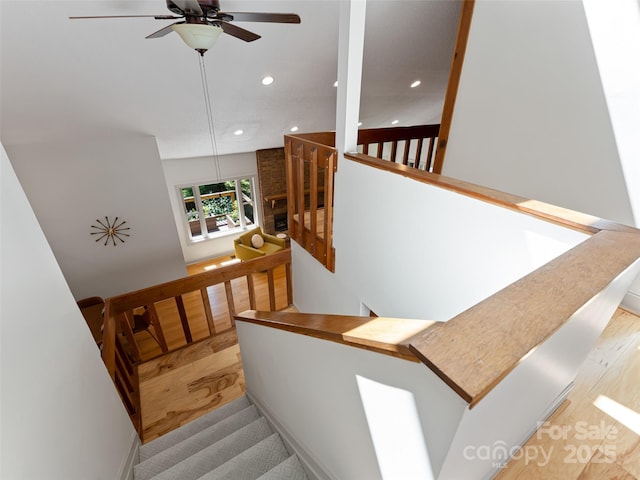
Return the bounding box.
[162,152,262,263]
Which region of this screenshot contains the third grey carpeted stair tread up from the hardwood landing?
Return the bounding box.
[146,417,273,480]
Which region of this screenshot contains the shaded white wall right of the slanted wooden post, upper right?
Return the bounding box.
[443,0,637,225]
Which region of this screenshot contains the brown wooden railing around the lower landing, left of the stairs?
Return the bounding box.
[102,249,293,433]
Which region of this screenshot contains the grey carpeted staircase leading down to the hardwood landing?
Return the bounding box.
[134,396,308,480]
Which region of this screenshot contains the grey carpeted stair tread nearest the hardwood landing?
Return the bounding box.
[140,395,250,462]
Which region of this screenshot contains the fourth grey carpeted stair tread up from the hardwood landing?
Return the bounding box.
[192,433,290,480]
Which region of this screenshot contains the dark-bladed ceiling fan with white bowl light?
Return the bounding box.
[69,0,300,55]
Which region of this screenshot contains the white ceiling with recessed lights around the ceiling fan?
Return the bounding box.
[0,0,460,158]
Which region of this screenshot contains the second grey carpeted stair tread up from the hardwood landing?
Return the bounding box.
[133,405,260,480]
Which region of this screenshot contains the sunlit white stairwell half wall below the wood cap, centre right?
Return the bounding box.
[293,159,587,320]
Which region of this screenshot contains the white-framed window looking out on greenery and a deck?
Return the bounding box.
[179,177,258,241]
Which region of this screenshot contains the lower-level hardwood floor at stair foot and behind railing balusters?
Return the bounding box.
[136,257,288,443]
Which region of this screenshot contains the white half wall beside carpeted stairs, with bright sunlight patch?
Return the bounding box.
[237,321,466,480]
